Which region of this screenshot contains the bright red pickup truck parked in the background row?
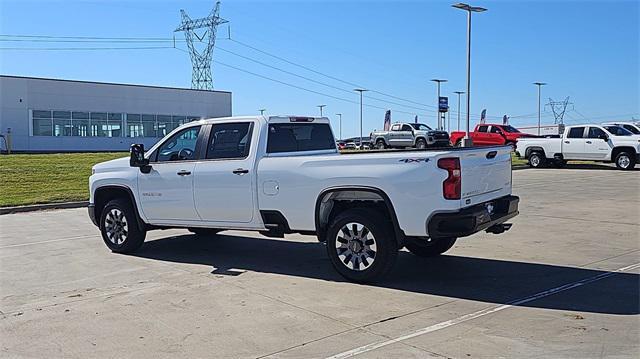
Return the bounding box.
[449,123,537,146]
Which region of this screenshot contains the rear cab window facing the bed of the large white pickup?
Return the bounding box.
[267,123,336,153]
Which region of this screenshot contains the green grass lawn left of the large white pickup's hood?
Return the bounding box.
[0,152,128,207]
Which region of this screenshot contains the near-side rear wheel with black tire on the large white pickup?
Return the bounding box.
[326,208,398,283]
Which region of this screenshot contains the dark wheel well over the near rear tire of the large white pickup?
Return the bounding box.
[315,187,404,244]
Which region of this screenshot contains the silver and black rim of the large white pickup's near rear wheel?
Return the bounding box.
[336,222,377,271]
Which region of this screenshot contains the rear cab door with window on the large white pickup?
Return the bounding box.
[194,121,256,223]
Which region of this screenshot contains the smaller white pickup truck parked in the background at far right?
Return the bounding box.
[516,125,640,170]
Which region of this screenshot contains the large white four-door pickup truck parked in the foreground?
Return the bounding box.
[89,116,519,282]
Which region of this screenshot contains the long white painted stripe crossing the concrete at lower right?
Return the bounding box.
[327,263,640,359]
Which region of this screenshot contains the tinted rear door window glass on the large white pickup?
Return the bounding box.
[207,122,253,159]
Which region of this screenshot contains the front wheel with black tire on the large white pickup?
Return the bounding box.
[100,198,147,253]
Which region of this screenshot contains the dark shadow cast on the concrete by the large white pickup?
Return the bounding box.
[134,234,640,315]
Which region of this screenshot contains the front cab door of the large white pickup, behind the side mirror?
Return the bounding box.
[138,126,200,224]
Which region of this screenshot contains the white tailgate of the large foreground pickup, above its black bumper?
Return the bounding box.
[460,146,511,207]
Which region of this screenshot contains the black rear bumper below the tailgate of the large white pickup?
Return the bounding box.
[427,196,520,238]
